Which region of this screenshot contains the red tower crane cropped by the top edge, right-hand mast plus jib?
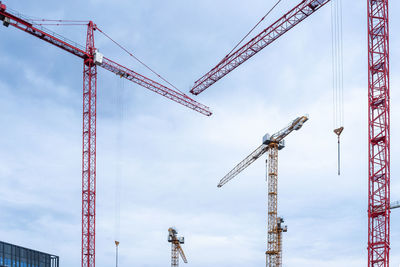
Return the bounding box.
[190,0,390,267]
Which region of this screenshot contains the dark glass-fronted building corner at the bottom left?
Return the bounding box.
[0,241,59,267]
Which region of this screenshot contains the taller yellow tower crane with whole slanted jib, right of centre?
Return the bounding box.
[218,116,308,267]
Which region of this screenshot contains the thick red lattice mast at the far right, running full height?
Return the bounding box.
[368,0,390,267]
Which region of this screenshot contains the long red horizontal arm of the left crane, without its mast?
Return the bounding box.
[0,2,212,116]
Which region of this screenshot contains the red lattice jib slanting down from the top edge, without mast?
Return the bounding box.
[190,0,330,95]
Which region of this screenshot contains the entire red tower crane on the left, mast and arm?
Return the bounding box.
[0,1,212,267]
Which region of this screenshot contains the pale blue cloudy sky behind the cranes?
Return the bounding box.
[0,0,400,267]
